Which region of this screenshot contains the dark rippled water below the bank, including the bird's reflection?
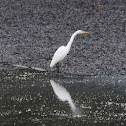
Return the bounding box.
[0,70,126,126]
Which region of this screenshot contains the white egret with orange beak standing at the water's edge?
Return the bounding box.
[50,30,88,68]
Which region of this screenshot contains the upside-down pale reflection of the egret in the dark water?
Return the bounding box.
[50,80,80,116]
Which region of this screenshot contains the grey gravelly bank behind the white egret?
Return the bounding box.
[0,0,126,75]
